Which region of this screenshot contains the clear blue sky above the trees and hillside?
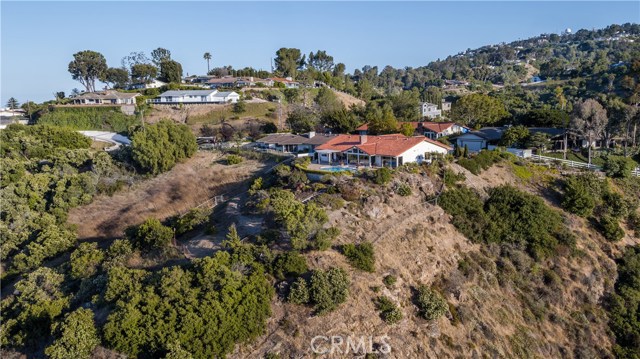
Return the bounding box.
[0,1,640,106]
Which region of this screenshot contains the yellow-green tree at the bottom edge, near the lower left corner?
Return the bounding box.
[45,308,100,359]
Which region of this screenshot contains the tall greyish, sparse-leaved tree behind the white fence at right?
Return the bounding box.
[571,99,608,164]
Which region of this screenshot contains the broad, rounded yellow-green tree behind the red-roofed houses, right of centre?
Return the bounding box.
[451,93,509,128]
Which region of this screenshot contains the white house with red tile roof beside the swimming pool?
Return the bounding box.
[315,135,451,167]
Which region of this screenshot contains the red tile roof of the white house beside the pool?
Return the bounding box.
[316,134,451,157]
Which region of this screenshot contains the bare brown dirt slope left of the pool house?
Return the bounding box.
[68,152,268,240]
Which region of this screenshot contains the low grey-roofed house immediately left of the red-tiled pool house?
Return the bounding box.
[256,132,338,153]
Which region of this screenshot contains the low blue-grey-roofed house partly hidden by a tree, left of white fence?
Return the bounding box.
[456,127,566,152]
